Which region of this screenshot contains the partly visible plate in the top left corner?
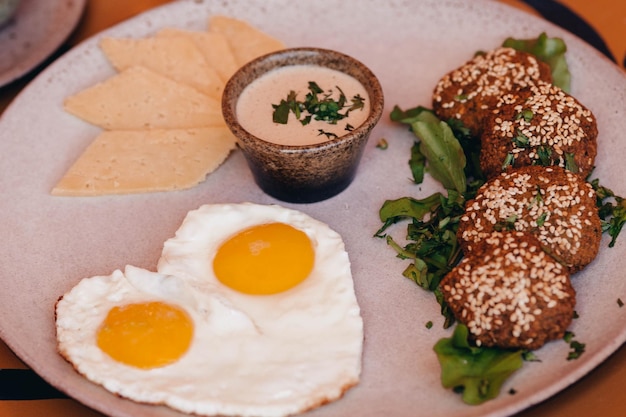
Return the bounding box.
[0,0,85,87]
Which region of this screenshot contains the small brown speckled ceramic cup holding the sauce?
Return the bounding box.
[222,48,384,203]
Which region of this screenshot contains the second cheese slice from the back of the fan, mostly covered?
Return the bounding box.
[156,28,239,83]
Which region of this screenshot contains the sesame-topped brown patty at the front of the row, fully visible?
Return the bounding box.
[440,232,576,349]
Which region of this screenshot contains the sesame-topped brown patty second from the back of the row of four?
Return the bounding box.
[480,83,598,178]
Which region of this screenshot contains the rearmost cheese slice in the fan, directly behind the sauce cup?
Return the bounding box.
[208,15,285,66]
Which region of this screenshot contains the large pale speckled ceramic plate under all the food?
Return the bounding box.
[0,0,626,417]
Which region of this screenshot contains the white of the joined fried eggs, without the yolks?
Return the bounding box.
[56,203,363,416]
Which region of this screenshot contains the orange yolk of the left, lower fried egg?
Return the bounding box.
[98,301,193,369]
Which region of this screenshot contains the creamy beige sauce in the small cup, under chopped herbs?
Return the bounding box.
[237,65,370,146]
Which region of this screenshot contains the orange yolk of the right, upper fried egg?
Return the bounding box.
[213,223,315,295]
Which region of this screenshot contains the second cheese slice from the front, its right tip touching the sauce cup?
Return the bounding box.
[64,67,224,130]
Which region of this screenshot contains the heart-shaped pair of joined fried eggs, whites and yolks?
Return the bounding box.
[56,203,363,416]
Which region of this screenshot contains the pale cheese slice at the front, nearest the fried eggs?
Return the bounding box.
[52,127,235,196]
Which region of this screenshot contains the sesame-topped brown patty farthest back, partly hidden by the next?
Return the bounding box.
[433,47,552,136]
